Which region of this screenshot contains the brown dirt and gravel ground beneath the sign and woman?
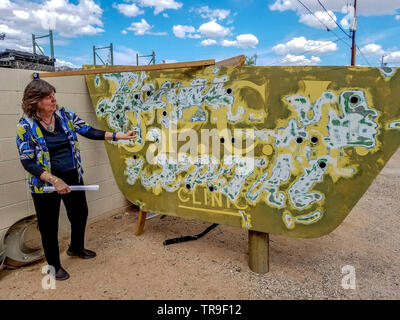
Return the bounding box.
[0,151,400,299]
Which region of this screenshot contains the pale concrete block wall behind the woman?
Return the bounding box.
[0,68,130,238]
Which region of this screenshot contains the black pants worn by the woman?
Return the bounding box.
[32,170,88,271]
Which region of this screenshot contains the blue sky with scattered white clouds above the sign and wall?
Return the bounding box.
[0,0,400,67]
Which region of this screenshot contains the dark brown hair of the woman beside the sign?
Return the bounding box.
[22,79,58,119]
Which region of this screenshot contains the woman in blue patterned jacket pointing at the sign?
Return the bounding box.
[17,79,134,280]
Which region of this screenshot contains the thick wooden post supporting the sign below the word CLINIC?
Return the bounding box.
[249,230,269,273]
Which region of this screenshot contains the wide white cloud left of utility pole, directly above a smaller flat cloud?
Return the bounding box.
[272,37,338,55]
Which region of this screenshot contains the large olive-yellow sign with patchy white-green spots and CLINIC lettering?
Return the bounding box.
[86,67,400,238]
